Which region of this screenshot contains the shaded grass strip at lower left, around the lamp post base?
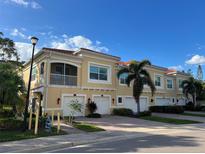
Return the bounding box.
[0,128,67,142]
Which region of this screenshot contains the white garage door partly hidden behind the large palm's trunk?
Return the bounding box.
[124,97,148,113]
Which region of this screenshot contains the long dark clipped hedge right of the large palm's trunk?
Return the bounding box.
[150,106,184,113]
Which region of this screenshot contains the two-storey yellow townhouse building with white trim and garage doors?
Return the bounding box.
[22,48,189,116]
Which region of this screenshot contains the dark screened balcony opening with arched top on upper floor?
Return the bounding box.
[50,63,77,86]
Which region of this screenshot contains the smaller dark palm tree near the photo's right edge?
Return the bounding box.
[182,77,203,107]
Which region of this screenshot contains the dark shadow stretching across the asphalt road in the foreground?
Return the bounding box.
[55,135,198,153]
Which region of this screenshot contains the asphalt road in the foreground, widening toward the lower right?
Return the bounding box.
[45,130,205,153]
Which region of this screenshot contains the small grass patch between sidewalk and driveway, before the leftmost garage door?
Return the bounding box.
[73,122,105,132]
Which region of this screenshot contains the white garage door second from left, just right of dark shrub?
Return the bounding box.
[93,96,111,114]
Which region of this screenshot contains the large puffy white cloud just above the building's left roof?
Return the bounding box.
[51,34,109,52]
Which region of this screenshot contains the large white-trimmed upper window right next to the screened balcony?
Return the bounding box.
[89,65,109,81]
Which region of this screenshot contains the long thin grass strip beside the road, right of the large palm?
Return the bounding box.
[140,116,201,125]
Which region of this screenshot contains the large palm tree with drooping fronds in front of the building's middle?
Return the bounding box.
[117,60,156,113]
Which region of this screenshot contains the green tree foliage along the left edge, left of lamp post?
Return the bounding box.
[0,32,25,113]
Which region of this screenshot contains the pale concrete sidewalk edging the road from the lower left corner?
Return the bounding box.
[0,131,142,153]
